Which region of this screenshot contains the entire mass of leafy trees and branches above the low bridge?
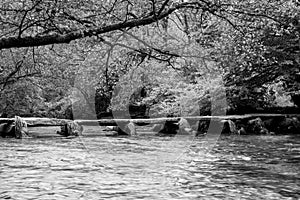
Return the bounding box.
[0,0,300,116]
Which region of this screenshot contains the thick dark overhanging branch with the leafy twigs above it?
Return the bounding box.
[0,0,207,49]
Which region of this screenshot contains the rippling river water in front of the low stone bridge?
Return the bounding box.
[0,132,300,200]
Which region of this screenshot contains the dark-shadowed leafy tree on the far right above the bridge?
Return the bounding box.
[220,1,300,112]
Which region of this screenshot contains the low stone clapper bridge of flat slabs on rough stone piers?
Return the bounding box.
[0,114,300,138]
